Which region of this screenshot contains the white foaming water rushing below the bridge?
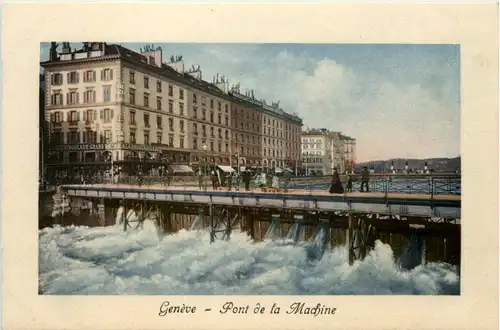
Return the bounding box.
[39,221,460,295]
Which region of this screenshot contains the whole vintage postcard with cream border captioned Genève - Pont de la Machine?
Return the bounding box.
[3,3,498,329]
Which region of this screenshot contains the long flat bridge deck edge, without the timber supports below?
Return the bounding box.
[63,184,461,218]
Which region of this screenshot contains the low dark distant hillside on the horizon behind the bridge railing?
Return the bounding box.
[356,157,461,172]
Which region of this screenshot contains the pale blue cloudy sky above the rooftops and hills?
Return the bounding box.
[40,43,460,162]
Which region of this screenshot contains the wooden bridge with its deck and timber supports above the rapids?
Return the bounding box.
[57,184,461,263]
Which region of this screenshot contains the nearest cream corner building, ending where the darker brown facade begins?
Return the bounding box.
[41,43,231,179]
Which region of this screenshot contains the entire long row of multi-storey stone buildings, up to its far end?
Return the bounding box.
[41,42,302,176]
